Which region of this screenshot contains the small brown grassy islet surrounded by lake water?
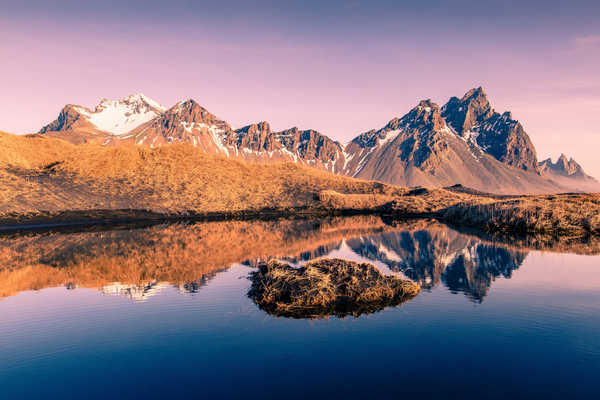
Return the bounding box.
[248,259,420,318]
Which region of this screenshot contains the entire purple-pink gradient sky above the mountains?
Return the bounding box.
[0,0,600,177]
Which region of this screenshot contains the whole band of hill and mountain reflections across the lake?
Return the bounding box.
[0,216,598,302]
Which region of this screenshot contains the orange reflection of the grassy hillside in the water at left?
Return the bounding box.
[0,216,393,297]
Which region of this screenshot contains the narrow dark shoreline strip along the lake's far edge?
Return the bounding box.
[0,207,600,239]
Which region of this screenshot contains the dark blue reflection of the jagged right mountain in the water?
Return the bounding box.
[347,227,527,300]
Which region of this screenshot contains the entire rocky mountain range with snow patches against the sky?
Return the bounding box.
[39,87,600,193]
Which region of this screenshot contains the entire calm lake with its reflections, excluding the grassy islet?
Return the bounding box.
[0,216,600,399]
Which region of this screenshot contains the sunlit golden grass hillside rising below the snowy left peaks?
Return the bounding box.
[0,138,403,219]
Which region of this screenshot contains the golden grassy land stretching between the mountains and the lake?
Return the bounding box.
[0,133,600,236]
